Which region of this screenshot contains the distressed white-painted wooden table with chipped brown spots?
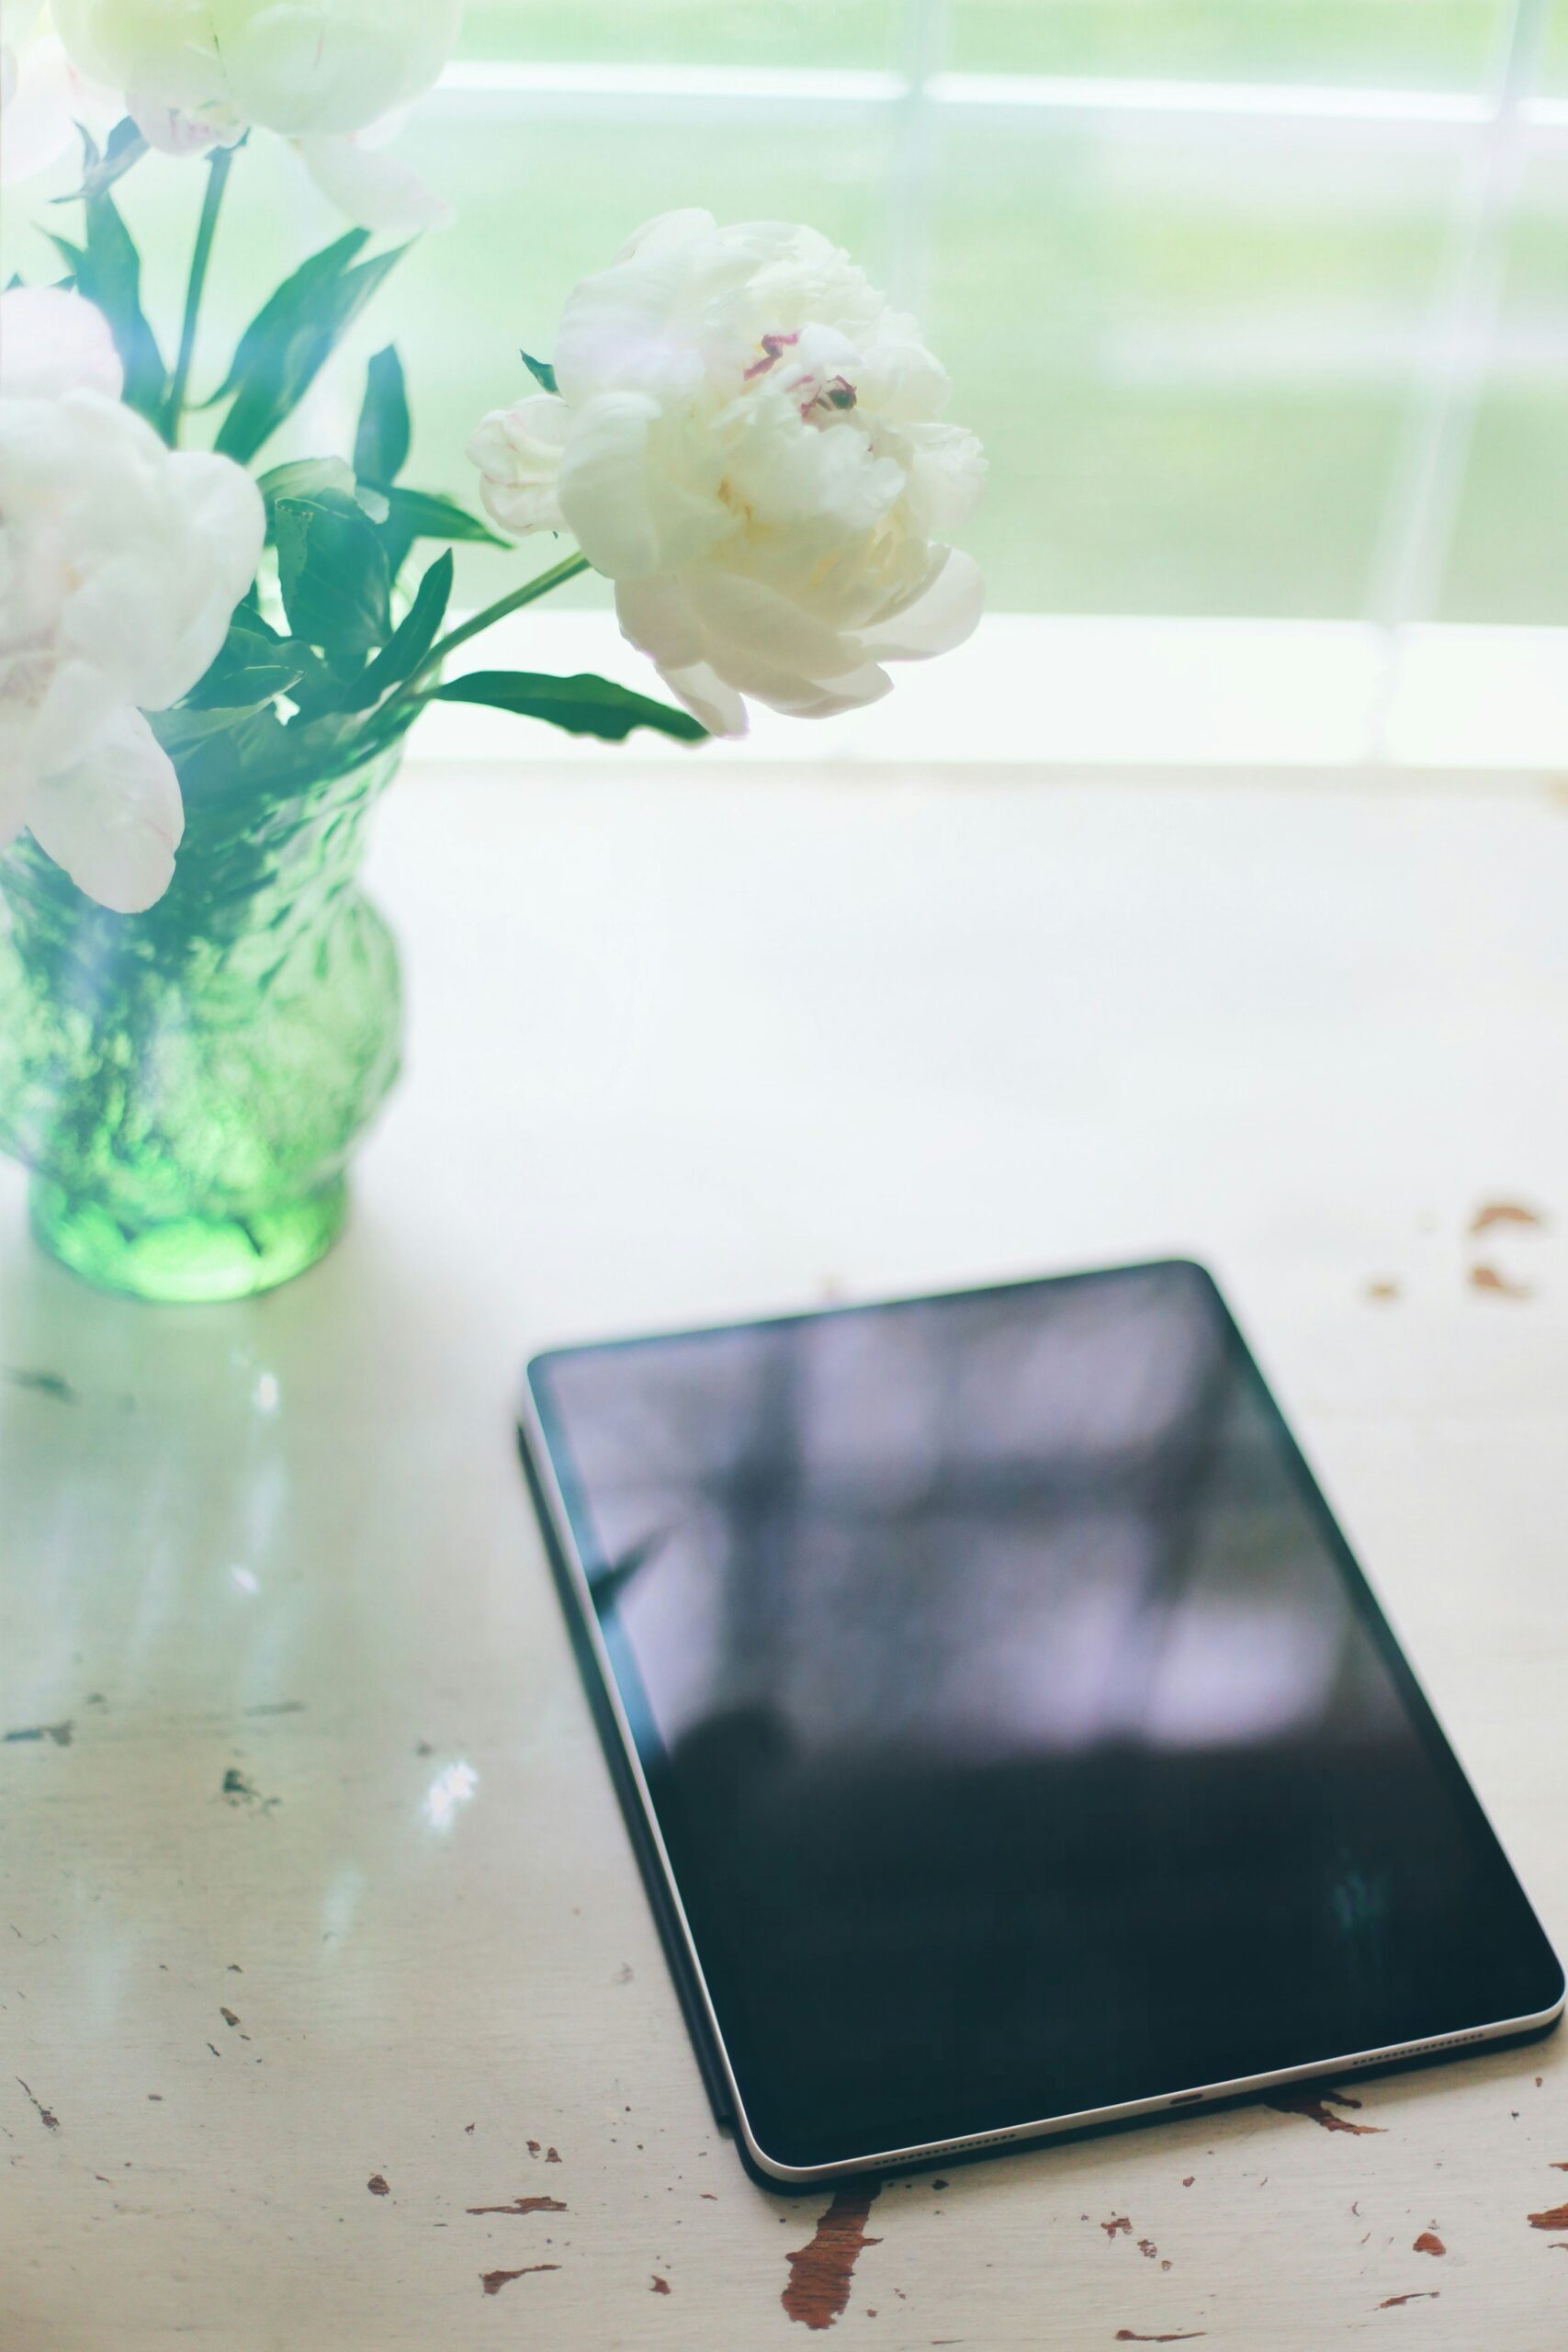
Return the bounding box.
[0,755,1568,2352]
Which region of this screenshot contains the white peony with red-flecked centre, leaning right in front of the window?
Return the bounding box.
[468,211,985,734]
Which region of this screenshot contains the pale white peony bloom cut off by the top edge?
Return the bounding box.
[54,0,463,232]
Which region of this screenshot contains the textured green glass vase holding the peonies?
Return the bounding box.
[0,746,402,1301]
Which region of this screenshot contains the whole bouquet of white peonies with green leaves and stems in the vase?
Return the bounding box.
[0,0,983,1296]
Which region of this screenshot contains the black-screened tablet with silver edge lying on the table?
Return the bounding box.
[522,1263,1563,2183]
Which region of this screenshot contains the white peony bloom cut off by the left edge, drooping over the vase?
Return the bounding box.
[0,289,264,915]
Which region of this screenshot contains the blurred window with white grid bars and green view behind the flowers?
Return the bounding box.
[3,0,1568,752]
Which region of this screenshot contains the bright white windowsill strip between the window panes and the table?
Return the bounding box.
[412,612,1568,786]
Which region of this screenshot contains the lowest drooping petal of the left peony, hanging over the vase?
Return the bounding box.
[28,703,186,915]
